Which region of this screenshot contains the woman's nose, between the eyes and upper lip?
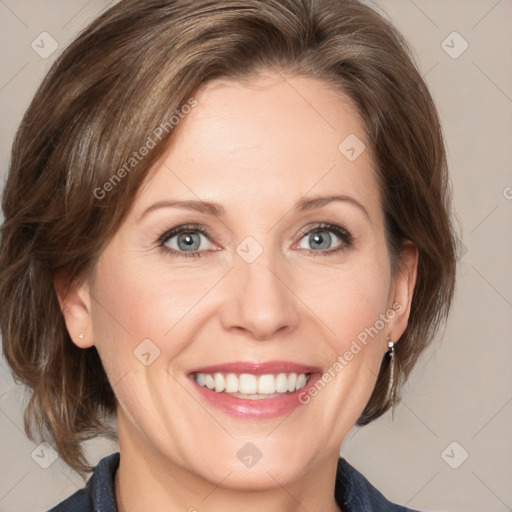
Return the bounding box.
[220,255,300,341]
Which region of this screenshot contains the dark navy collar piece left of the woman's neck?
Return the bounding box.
[48,452,119,512]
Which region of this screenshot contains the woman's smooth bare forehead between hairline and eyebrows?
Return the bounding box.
[135,75,380,221]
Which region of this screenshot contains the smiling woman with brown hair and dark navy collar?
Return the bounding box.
[0,0,455,512]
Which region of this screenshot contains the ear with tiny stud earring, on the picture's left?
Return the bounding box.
[53,274,94,348]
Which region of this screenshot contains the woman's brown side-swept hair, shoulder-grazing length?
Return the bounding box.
[0,0,455,474]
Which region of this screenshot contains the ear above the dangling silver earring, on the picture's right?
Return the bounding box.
[389,240,418,342]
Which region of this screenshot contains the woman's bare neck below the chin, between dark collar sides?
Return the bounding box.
[115,416,340,512]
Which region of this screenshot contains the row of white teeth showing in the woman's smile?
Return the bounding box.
[195,372,309,398]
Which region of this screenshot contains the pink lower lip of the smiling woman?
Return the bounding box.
[191,373,322,419]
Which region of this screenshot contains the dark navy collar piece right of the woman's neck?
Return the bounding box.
[335,458,418,512]
